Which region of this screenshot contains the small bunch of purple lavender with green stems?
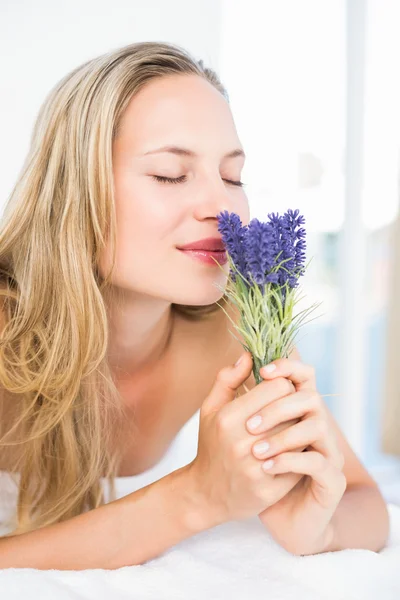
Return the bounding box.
[218,210,318,384]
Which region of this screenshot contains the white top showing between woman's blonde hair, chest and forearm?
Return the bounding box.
[0,410,200,535]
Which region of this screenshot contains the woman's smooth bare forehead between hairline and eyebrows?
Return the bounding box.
[117,75,240,152]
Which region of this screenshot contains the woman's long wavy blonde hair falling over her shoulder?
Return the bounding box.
[0,43,226,534]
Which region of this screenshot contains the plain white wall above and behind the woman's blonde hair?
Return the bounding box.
[0,0,221,210]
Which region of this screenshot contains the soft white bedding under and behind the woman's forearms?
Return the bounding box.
[0,415,400,600]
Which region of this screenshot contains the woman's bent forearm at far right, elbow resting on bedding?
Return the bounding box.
[324,485,389,552]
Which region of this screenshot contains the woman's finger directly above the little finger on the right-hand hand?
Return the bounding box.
[252,417,337,462]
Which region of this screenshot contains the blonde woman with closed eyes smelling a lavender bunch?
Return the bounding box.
[0,43,388,569]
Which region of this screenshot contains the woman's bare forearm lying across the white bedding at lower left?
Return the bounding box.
[0,467,212,570]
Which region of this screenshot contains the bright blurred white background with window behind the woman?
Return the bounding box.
[0,0,400,503]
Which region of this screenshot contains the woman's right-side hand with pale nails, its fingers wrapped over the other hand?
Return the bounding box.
[247,359,346,555]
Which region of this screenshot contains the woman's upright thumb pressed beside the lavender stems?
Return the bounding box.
[203,352,253,412]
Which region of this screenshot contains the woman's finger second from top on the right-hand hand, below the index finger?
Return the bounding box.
[246,392,321,435]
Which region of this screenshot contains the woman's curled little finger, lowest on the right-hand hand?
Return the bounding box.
[262,451,346,495]
